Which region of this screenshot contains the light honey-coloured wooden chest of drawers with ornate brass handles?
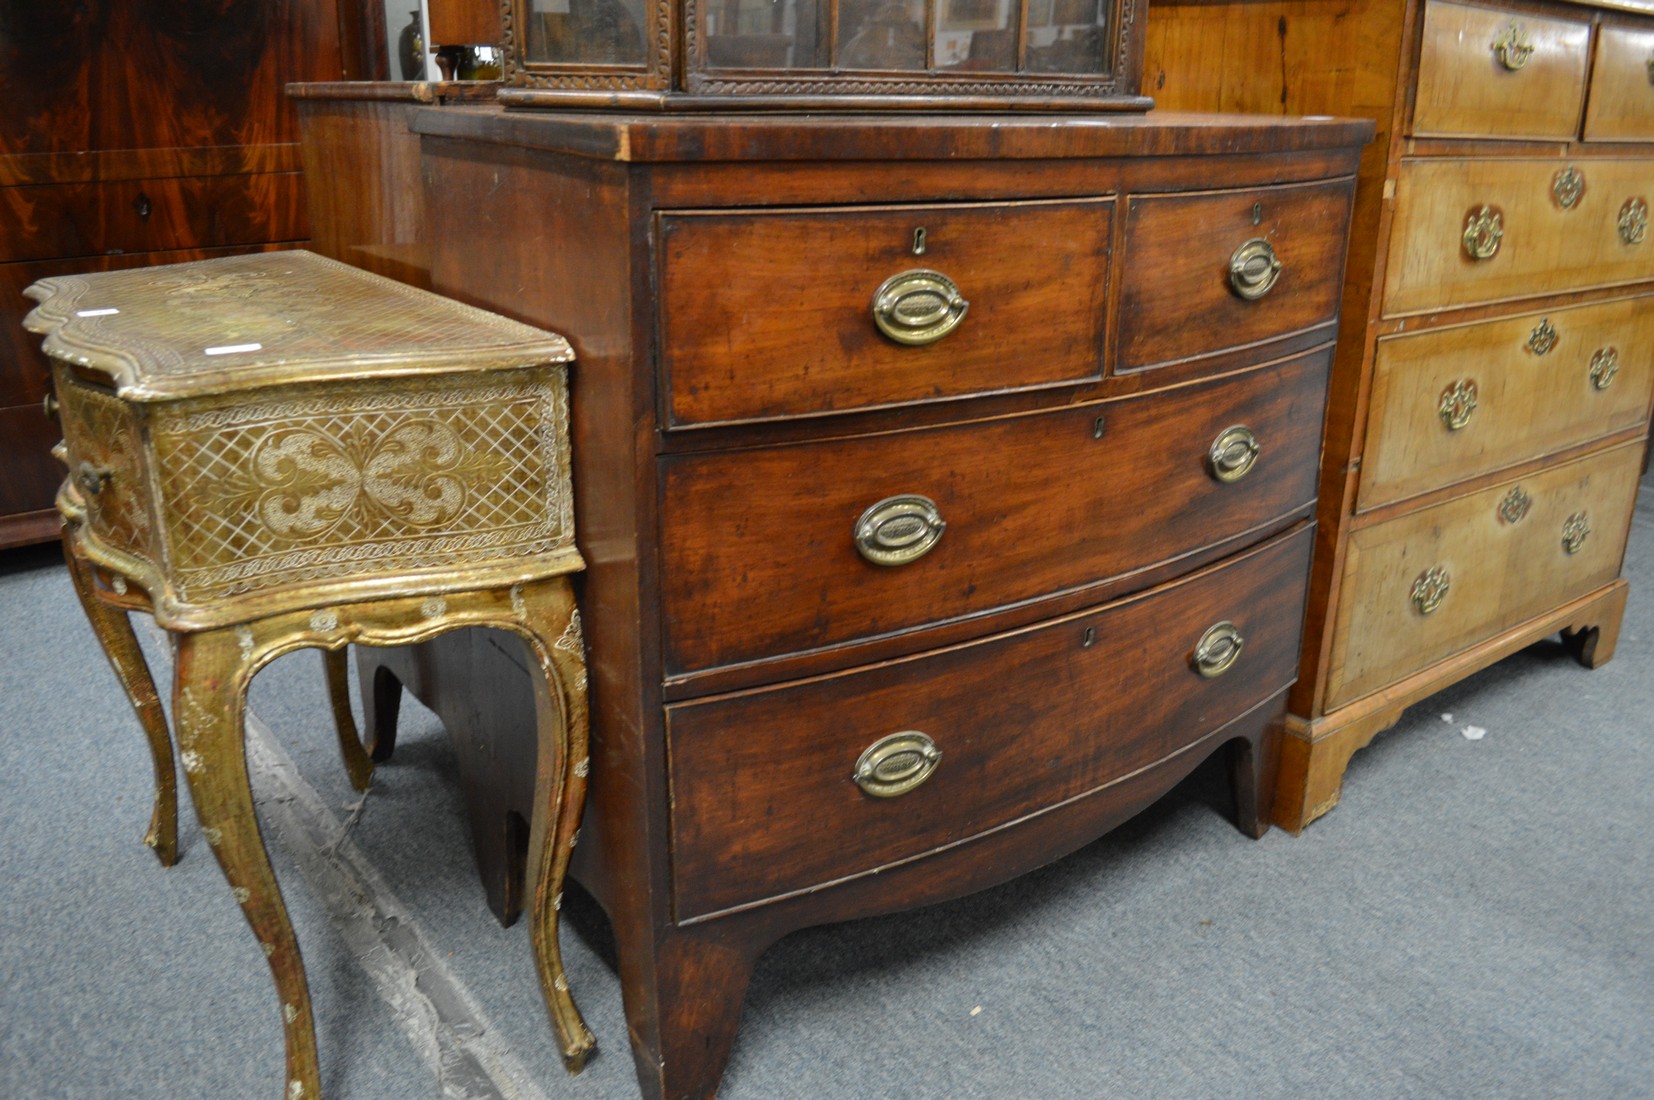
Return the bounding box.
[1146,0,1654,829]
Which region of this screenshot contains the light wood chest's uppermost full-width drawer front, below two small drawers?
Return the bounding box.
[1384,157,1654,316]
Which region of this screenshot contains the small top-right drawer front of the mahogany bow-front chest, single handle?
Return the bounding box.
[1120,180,1355,371]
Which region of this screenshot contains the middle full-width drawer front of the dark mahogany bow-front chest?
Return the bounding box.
[660,352,1328,675]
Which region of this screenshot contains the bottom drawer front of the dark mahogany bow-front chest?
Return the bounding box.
[667,528,1312,921]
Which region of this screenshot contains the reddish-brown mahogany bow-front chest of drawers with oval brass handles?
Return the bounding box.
[297,100,1370,1097]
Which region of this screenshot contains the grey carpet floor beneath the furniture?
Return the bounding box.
[0,473,1654,1100]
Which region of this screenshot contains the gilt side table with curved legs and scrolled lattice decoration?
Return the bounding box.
[26,251,592,1100]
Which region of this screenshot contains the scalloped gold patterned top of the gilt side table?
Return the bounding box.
[23,251,574,400]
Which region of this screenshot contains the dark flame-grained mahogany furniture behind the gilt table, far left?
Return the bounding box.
[0,0,359,546]
